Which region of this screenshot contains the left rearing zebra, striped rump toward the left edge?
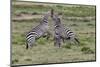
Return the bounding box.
[26,13,50,49]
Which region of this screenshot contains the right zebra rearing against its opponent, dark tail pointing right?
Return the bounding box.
[51,10,80,47]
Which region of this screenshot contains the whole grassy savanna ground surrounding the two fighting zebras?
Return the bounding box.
[11,1,96,65]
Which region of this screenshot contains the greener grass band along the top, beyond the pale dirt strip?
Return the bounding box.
[12,2,95,17]
